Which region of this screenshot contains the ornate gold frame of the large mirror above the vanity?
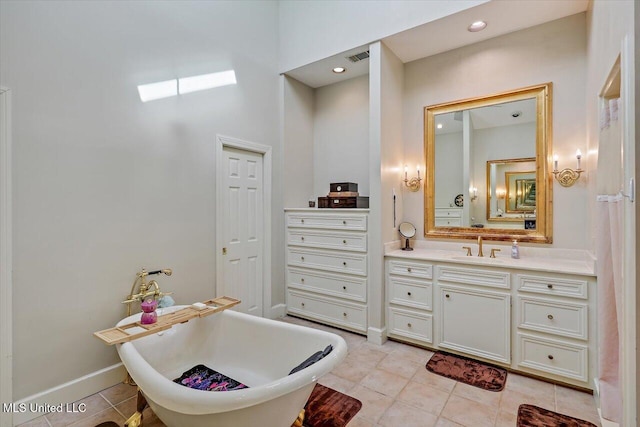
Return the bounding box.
[423,82,553,243]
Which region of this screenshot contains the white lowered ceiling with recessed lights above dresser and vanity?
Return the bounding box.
[285,0,589,88]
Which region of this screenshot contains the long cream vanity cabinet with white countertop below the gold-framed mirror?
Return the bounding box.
[385,249,597,389]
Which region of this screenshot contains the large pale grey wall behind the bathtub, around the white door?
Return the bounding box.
[0,1,284,400]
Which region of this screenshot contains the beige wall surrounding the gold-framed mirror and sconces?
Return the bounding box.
[404,14,588,249]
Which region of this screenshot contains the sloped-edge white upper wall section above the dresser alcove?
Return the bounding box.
[279,0,486,72]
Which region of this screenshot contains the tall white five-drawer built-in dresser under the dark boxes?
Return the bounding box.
[285,208,369,334]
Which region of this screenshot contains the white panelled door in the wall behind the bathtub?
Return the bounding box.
[218,147,264,316]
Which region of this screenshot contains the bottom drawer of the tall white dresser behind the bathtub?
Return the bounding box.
[287,290,367,333]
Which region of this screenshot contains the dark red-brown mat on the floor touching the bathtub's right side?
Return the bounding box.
[303,384,362,427]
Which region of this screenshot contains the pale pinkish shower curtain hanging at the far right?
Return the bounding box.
[596,99,624,423]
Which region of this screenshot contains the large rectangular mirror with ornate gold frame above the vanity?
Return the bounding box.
[424,83,553,243]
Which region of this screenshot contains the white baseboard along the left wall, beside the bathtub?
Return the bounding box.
[13,363,127,426]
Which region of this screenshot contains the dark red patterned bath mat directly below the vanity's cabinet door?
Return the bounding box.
[427,351,507,391]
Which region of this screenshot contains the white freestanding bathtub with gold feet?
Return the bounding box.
[116,306,347,427]
